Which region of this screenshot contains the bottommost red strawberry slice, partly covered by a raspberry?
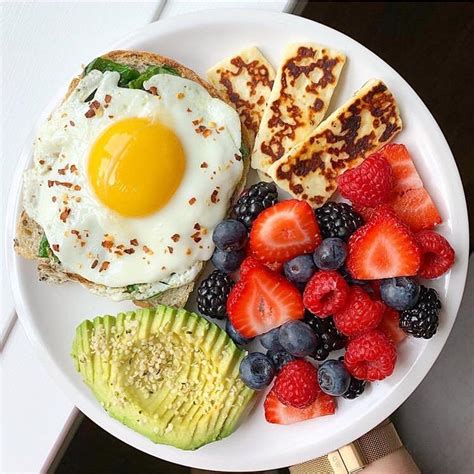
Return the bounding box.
[264,389,336,425]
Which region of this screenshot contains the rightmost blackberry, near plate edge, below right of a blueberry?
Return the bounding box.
[400,285,441,339]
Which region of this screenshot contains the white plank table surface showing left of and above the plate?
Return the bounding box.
[0,0,292,473]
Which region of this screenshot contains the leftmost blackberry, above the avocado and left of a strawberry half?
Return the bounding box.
[196,270,234,319]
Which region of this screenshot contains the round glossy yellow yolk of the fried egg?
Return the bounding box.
[88,118,185,217]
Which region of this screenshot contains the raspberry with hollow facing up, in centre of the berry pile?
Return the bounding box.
[303,270,349,318]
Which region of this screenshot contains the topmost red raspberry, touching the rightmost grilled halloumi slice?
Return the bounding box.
[337,153,392,207]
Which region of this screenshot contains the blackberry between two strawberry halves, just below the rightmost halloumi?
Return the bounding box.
[316,202,364,241]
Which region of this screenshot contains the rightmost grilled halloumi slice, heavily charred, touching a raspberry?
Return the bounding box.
[268,79,402,207]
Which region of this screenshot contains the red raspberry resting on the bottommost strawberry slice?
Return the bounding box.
[275,359,321,408]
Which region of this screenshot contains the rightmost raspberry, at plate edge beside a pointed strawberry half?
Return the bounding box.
[416,230,455,278]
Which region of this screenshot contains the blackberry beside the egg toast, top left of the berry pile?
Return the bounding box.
[234,181,278,229]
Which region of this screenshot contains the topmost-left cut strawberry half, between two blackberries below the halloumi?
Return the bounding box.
[250,199,321,263]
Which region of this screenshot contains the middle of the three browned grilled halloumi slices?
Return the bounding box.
[252,43,346,173]
